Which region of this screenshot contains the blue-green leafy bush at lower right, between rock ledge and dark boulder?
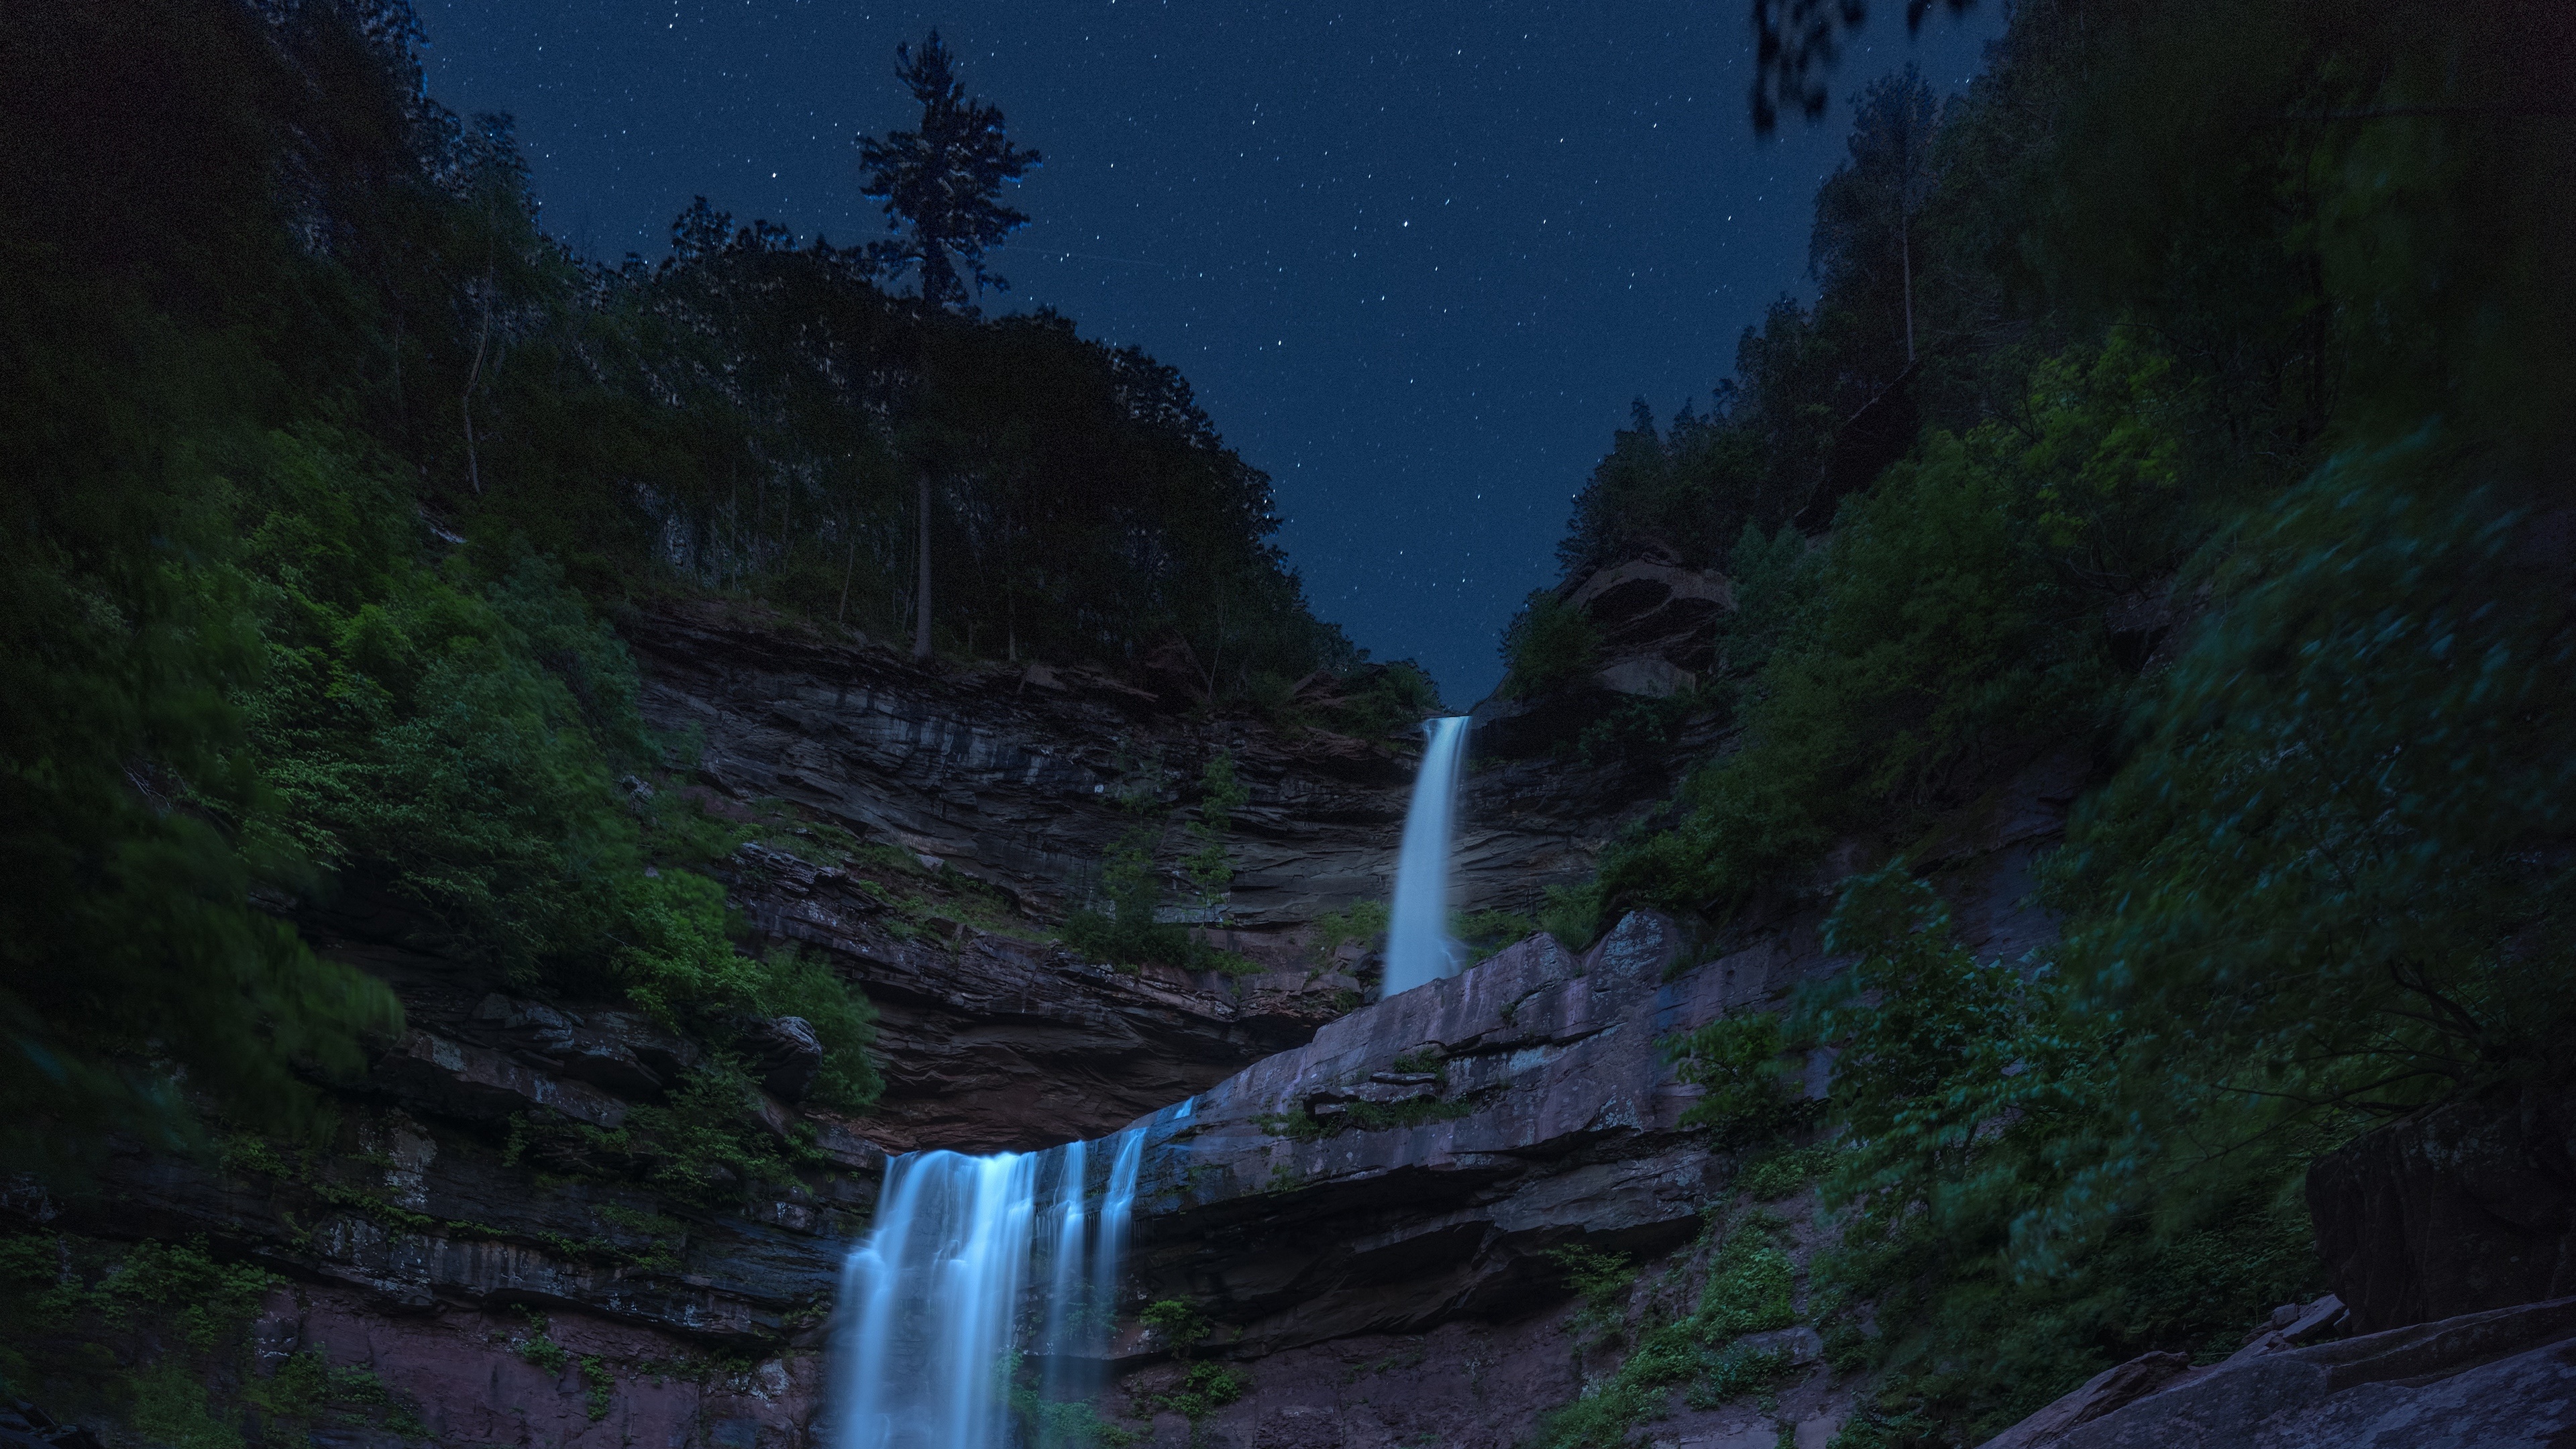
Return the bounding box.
[1803,866,2321,1434]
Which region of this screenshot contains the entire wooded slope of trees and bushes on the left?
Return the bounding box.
[0,0,1383,1165]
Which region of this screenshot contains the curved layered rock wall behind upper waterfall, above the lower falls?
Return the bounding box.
[626,595,1731,1152]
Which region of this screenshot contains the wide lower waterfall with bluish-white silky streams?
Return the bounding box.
[832,1127,1144,1449]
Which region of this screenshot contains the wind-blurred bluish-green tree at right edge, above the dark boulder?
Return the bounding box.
[2040,436,2576,1258]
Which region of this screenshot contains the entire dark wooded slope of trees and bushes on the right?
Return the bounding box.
[1515,0,2576,1444]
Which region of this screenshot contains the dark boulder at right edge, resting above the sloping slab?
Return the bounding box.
[2308,1080,2576,1333]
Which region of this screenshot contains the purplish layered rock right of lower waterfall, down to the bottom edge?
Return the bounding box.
[1081,737,2082,1449]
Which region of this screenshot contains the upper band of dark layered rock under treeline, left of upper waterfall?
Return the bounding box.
[623,606,1411,930]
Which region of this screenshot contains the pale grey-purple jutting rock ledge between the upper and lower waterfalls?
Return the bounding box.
[1136,915,1721,1354]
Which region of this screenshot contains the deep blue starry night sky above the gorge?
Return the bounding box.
[420,0,2004,709]
